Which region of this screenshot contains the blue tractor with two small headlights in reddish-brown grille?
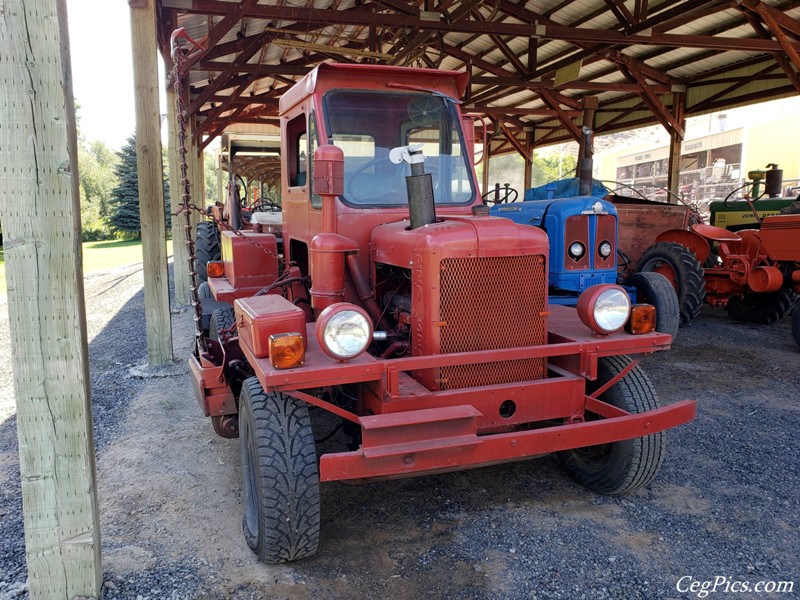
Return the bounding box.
[486,187,680,336]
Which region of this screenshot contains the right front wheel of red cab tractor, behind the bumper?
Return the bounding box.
[558,356,666,494]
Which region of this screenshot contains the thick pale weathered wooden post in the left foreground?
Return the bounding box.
[0,0,103,600]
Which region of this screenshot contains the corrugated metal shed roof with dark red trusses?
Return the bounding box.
[157,0,800,154]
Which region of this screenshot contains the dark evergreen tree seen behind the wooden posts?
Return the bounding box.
[108,134,171,238]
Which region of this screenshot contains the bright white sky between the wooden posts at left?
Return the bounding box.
[67,0,166,150]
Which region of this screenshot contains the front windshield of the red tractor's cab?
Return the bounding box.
[325,90,474,206]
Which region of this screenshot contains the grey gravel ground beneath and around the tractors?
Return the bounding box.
[0,268,800,600]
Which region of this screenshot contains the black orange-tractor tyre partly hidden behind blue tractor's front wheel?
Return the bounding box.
[637,242,706,327]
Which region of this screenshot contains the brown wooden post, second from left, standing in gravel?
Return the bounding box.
[130,0,172,366]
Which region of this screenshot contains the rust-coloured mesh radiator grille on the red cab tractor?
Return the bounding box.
[440,255,547,390]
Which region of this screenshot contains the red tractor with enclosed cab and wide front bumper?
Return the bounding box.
[190,64,695,563]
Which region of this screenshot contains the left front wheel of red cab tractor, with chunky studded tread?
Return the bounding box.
[239,377,320,564]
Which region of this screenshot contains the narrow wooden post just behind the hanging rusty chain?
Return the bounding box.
[167,80,191,304]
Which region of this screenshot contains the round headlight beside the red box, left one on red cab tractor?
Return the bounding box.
[317,302,372,360]
